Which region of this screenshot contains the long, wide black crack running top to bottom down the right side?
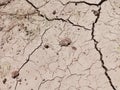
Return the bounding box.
[91,0,116,90]
